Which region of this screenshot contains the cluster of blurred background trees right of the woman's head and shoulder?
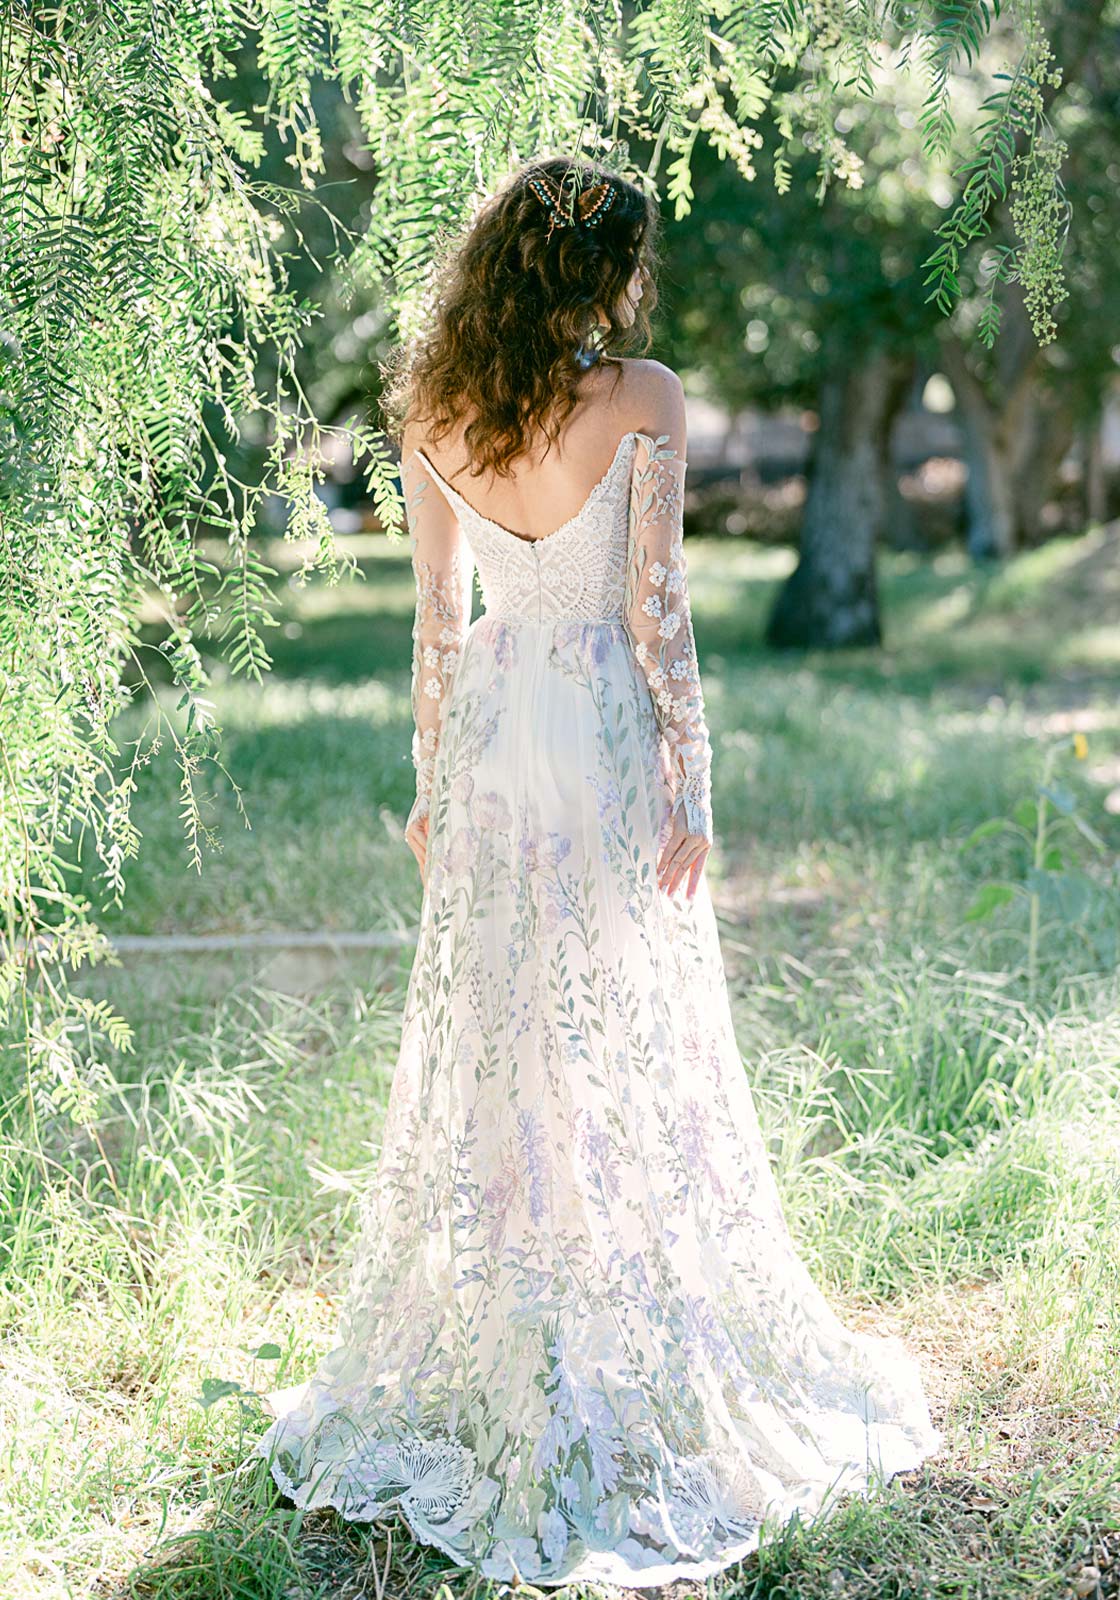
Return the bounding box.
[666,3,1120,646]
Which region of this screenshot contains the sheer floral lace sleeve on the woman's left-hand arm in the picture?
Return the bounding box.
[400,451,474,826]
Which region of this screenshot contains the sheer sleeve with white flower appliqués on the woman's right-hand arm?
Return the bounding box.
[626,434,712,842]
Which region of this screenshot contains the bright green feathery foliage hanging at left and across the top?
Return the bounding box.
[0,0,1064,1088]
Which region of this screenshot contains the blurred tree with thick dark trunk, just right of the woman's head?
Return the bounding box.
[669,85,947,646]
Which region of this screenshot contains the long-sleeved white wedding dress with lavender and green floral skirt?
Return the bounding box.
[256,432,942,1587]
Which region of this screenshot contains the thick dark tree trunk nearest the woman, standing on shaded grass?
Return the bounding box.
[766,342,912,650]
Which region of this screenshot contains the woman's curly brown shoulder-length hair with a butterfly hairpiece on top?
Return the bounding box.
[381,155,658,477]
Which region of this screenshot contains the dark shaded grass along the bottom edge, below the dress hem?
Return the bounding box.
[96,1451,1120,1600]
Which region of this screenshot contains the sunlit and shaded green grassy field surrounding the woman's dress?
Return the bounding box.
[0,533,1120,1600]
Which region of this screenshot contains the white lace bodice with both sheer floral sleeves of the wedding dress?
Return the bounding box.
[402,430,712,840]
